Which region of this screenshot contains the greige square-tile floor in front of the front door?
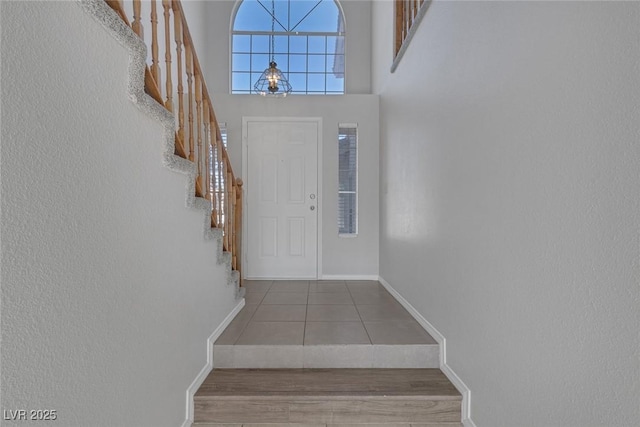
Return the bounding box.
[216,280,436,346]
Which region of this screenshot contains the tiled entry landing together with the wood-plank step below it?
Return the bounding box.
[194,280,462,427]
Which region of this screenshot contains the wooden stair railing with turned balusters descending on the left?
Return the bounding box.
[105,0,242,288]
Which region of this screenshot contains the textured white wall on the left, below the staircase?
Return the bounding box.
[0,2,235,427]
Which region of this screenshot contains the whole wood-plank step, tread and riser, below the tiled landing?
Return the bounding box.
[194,369,462,427]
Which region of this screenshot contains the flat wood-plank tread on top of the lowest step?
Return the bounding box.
[195,368,462,400]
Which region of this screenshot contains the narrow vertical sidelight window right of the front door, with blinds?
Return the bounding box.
[338,125,358,234]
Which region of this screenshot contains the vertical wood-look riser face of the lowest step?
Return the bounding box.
[194,398,461,424]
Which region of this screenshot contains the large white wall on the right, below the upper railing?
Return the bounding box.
[373,2,640,427]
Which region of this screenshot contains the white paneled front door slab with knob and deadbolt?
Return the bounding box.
[244,118,320,279]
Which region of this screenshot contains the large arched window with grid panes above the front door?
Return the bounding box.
[231,0,344,94]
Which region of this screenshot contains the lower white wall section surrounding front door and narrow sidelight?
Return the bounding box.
[213,94,379,277]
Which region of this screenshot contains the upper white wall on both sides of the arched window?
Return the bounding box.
[195,0,371,94]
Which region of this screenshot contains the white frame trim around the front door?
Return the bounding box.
[242,116,324,279]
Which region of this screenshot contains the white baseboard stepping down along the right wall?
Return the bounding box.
[378,276,476,427]
